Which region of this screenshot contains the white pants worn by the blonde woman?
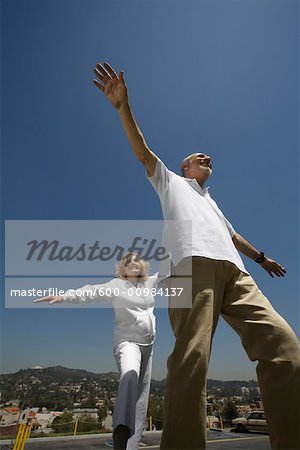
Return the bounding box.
[113,341,153,450]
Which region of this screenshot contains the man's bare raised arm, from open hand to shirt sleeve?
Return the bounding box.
[93,63,157,177]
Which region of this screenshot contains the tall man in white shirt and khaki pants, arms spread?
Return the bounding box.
[94,63,300,450]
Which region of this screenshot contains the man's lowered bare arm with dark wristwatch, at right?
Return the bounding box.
[232,233,286,278]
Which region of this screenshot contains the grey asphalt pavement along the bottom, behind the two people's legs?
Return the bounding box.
[1,431,271,450]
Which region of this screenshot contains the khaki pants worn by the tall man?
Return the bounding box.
[161,257,300,450]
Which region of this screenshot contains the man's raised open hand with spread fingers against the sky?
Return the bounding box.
[93,63,128,109]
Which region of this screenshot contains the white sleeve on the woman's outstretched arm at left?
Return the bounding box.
[62,279,116,304]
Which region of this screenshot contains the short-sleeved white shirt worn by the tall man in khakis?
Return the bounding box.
[148,159,248,275]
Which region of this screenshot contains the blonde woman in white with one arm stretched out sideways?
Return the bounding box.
[34,253,157,450]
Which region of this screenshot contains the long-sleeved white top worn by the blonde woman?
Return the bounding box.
[63,273,158,346]
